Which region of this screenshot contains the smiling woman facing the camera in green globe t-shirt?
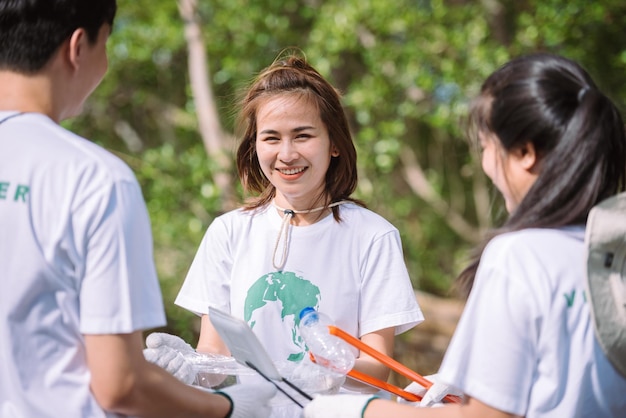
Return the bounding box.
[145,54,423,392]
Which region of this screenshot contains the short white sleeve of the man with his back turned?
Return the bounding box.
[73,180,165,334]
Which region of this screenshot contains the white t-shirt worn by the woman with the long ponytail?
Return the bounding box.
[439,227,626,418]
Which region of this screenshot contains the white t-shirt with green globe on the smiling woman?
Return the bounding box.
[176,204,423,361]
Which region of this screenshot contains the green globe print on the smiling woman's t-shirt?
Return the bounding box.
[244,271,320,362]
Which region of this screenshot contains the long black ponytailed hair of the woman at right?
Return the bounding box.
[457,54,626,296]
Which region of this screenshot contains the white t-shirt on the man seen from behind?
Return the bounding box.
[0,112,165,418]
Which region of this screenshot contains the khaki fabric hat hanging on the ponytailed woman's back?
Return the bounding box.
[585,193,626,377]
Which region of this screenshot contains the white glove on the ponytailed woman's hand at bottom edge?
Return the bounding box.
[304,395,378,418]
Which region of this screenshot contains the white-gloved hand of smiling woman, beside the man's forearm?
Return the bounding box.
[143,332,197,385]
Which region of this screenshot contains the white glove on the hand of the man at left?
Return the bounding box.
[215,382,276,418]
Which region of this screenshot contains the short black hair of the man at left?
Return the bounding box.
[0,0,117,74]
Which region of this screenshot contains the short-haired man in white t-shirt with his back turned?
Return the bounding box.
[0,0,276,418]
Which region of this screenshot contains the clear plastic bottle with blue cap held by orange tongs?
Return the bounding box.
[300,307,355,375]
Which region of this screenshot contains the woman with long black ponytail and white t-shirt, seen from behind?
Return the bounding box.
[304,54,626,418]
